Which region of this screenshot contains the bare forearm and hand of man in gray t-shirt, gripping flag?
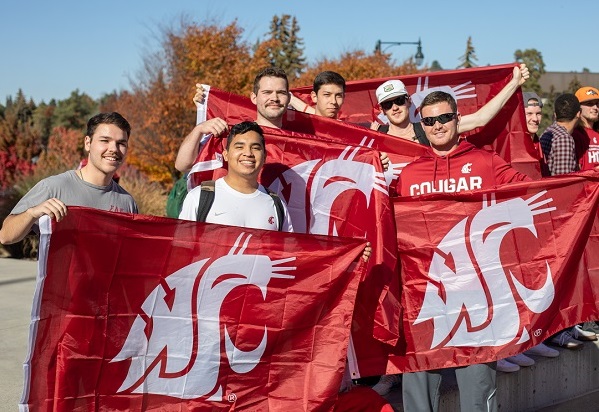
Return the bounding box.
[0,198,67,245]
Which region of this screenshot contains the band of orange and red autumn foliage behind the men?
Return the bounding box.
[0,15,426,196]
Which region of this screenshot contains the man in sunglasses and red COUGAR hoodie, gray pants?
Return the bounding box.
[397,91,531,411]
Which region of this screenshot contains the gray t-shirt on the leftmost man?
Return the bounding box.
[10,170,138,215]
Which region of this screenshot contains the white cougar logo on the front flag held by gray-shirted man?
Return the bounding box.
[112,233,296,401]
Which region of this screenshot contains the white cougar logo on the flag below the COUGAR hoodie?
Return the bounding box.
[414,191,556,348]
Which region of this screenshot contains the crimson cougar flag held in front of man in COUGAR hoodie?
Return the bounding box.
[388,172,599,372]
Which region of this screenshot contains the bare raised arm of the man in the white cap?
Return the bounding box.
[458,64,530,133]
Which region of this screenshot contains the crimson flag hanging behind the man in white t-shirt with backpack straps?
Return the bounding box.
[190,128,400,354]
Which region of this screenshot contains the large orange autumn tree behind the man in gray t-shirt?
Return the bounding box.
[102,19,268,186]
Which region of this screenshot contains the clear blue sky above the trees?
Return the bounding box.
[0,0,599,103]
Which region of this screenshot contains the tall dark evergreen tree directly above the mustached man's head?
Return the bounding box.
[265,14,306,81]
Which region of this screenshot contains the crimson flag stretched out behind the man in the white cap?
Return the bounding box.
[291,64,541,178]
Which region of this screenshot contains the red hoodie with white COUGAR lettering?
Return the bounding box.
[396,140,532,196]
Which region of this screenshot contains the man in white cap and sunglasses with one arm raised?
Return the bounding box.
[371,64,530,146]
